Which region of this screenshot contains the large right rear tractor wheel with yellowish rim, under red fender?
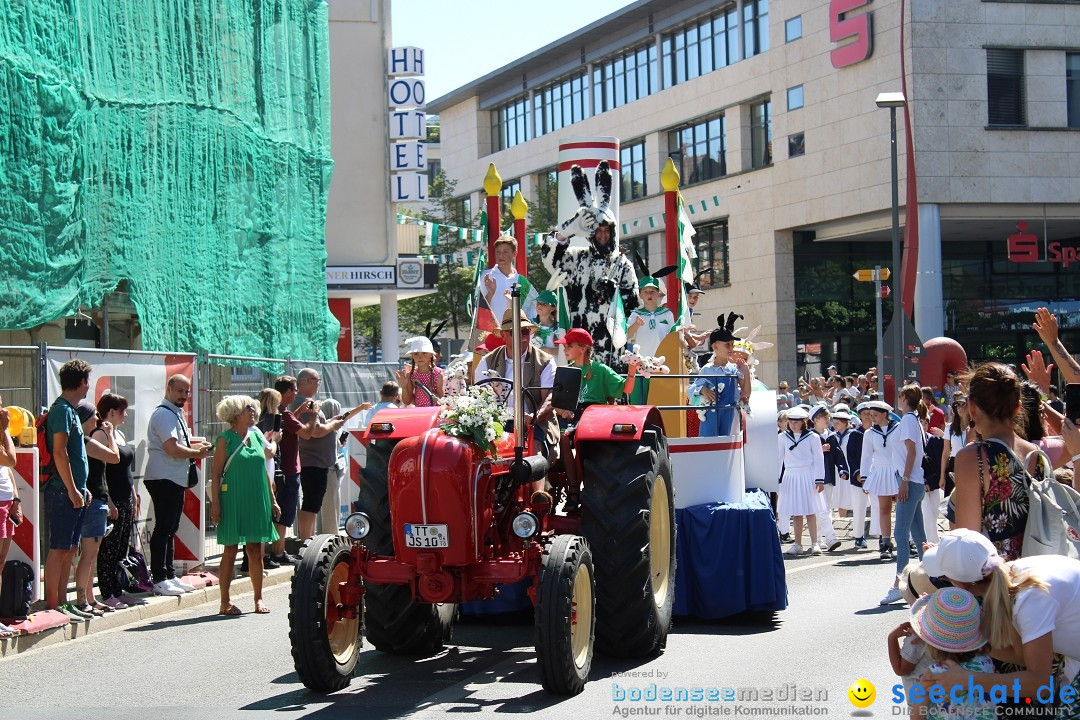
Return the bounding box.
[579,425,675,657]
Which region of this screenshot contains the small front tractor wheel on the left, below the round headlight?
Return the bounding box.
[288,535,361,692]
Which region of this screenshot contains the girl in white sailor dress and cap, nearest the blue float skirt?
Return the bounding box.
[777,408,825,555]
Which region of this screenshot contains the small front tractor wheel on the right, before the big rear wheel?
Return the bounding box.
[535,535,596,695]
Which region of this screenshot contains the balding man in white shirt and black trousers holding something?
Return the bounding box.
[145,375,214,595]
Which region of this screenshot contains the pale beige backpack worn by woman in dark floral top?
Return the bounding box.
[1023,450,1080,558]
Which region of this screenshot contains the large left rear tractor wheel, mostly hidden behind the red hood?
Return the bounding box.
[359,440,457,655]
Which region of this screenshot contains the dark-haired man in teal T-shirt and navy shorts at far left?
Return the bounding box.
[45,359,91,622]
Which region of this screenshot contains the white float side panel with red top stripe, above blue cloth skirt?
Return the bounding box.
[667,433,745,508]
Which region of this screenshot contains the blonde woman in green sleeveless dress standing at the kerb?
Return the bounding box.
[210,395,281,615]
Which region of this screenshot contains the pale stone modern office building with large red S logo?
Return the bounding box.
[428,0,1080,384]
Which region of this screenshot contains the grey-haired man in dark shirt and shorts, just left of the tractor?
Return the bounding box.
[293,367,346,542]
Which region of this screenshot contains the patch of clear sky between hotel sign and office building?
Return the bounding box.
[391,0,633,100]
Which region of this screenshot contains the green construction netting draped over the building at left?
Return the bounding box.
[0,0,338,359]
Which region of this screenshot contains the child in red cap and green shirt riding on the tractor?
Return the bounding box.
[555,327,639,512]
